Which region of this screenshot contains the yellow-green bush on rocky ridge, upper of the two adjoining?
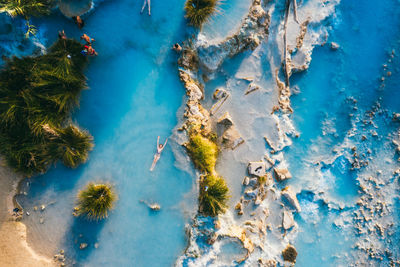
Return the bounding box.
[186,133,218,174]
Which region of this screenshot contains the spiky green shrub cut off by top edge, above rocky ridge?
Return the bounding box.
[185,0,219,28]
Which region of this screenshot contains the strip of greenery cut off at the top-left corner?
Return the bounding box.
[0,0,53,17]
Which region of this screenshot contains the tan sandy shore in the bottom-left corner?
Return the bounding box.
[0,161,56,267]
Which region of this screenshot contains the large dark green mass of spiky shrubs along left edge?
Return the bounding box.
[0,39,93,176]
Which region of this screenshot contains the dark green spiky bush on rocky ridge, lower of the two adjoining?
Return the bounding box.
[199,175,229,216]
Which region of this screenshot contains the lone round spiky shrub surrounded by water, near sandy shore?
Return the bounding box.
[76,183,117,221]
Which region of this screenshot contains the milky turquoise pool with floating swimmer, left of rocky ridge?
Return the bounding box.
[19,0,196,266]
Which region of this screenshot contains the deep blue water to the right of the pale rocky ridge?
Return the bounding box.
[286,1,400,266]
